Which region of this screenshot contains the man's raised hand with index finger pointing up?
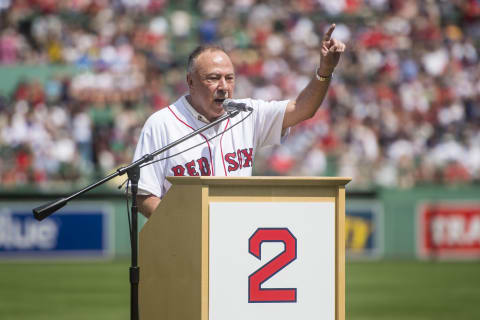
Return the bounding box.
[318,23,345,77]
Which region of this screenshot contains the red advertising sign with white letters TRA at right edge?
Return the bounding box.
[417,203,480,258]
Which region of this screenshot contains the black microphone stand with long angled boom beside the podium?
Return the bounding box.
[33,110,240,320]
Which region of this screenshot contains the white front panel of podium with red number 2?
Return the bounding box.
[209,202,335,320]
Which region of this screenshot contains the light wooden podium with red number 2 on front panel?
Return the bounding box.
[139,177,350,320]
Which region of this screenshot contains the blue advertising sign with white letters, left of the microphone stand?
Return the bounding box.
[0,205,113,258]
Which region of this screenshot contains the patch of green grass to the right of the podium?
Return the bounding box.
[346,261,480,320]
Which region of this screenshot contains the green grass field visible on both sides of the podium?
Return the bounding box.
[0,261,480,320]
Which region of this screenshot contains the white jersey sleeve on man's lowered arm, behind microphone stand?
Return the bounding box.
[133,119,165,198]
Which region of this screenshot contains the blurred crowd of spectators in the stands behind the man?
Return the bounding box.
[0,0,480,188]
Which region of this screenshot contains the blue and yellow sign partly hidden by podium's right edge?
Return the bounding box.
[345,201,383,258]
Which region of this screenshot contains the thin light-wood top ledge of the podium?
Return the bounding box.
[167,176,352,187]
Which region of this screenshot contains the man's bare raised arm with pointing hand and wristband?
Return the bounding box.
[282,24,345,129]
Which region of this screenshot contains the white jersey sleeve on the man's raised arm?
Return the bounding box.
[251,100,289,148]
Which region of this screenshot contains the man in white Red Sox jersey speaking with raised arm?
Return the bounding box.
[134,24,345,217]
